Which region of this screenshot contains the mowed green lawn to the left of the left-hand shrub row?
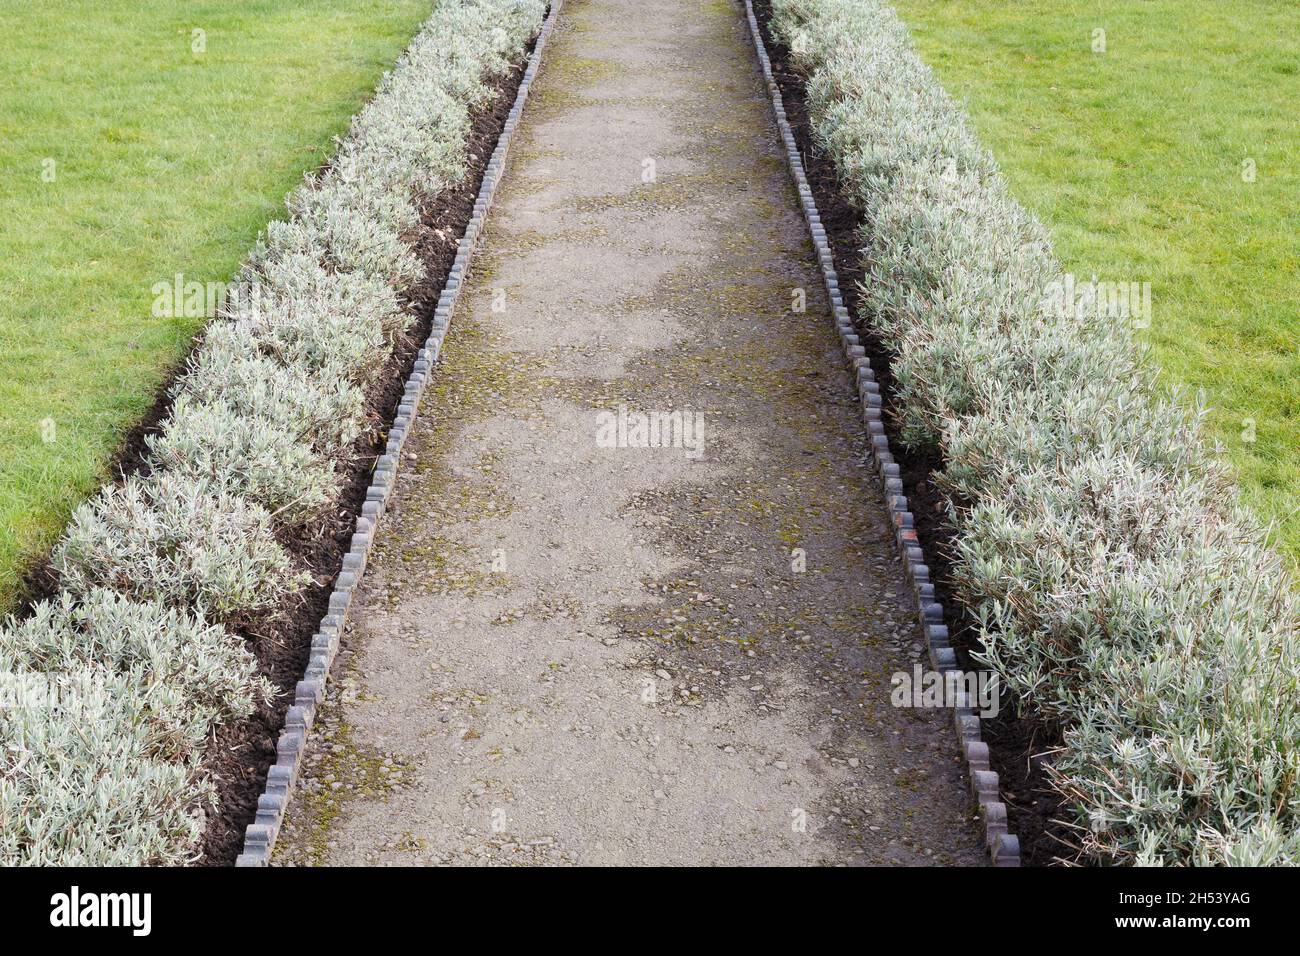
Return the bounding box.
[0,0,433,610]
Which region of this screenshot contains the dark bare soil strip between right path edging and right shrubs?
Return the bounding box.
[754,0,1075,866]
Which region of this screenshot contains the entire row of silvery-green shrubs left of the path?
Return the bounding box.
[0,0,546,866]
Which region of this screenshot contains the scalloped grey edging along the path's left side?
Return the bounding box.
[235,0,564,866]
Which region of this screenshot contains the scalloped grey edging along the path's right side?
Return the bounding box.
[745,0,1021,866]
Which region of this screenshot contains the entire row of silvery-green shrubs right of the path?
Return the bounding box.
[771,0,1300,865]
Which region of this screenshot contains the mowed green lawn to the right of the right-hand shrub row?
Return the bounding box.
[897,0,1300,562]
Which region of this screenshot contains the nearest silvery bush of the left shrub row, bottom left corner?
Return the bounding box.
[0,589,273,866]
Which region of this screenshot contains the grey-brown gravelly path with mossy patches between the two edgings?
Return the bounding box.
[276,0,982,865]
